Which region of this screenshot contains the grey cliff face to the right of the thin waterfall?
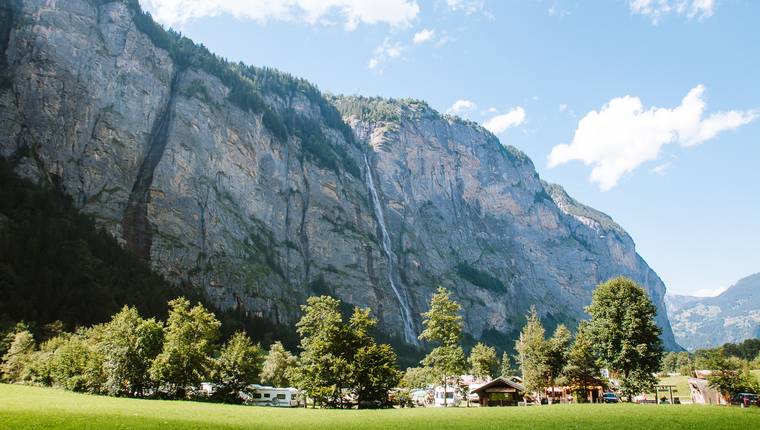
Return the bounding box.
[336,97,675,347]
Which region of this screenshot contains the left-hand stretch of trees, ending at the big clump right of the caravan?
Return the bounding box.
[0,296,401,407]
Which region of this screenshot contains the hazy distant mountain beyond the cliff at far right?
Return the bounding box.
[665,273,760,350]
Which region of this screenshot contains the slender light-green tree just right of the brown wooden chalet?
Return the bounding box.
[515,306,550,404]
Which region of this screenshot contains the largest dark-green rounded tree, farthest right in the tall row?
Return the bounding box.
[586,277,663,401]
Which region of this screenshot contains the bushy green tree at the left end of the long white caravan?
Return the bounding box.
[212,331,263,403]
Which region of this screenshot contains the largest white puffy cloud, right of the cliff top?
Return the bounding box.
[549,85,760,190]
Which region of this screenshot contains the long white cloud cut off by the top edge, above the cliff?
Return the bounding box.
[140,0,420,30]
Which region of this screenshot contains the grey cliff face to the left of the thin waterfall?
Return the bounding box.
[0,0,388,330]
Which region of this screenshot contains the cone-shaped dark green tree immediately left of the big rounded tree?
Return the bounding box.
[561,322,606,403]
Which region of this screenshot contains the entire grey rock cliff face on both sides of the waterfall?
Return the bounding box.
[0,0,676,348]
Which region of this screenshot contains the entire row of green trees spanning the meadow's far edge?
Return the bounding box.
[2,278,684,408]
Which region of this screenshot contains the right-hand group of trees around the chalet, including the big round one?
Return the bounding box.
[402,277,663,402]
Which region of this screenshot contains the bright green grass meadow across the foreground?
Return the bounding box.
[0,385,760,430]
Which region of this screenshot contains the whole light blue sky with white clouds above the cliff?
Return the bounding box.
[141,0,760,295]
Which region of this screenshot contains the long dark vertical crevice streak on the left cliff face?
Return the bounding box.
[121,69,184,261]
